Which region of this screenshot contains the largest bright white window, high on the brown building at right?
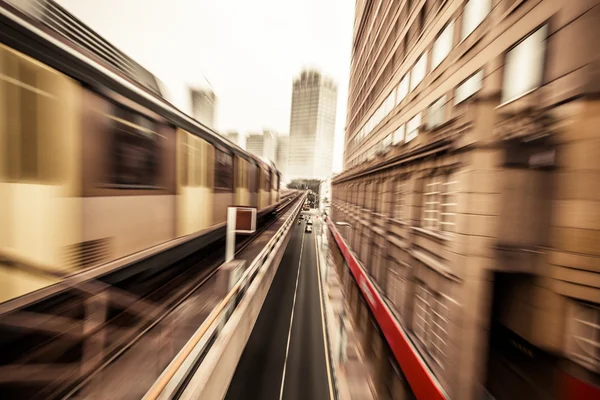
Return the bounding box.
[502,25,548,102]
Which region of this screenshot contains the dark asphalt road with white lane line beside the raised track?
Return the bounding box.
[226,209,332,400]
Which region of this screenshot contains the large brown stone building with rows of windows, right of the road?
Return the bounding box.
[330,0,600,399]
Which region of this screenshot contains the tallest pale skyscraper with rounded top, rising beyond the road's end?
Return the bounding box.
[288,70,337,179]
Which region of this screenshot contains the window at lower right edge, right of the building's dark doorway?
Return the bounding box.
[567,301,600,372]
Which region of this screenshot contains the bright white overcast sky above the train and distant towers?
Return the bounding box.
[58,0,354,171]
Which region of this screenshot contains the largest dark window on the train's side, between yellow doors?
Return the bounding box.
[110,105,160,188]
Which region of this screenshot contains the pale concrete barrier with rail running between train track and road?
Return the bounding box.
[144,195,305,400]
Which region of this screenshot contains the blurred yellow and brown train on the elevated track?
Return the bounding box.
[0,0,280,301]
